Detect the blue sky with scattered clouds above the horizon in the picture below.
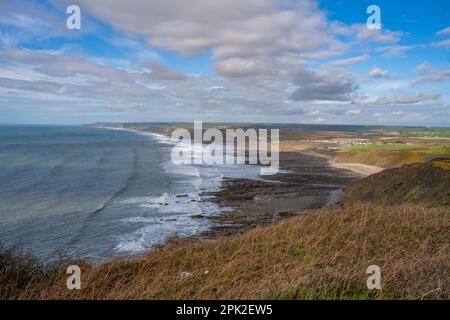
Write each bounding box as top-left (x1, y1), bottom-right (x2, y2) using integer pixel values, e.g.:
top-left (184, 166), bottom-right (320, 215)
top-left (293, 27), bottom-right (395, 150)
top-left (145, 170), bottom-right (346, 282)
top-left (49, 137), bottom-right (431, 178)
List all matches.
top-left (0, 0), bottom-right (450, 126)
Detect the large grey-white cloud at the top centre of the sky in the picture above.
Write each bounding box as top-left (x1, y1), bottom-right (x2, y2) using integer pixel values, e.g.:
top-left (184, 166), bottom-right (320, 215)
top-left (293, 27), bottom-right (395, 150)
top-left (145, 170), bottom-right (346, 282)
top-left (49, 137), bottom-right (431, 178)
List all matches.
top-left (74, 0), bottom-right (333, 58)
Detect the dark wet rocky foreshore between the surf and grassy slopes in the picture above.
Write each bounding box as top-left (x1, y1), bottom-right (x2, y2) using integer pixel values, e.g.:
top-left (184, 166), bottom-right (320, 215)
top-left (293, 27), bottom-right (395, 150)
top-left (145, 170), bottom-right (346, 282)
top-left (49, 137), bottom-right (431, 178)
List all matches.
top-left (202, 152), bottom-right (361, 238)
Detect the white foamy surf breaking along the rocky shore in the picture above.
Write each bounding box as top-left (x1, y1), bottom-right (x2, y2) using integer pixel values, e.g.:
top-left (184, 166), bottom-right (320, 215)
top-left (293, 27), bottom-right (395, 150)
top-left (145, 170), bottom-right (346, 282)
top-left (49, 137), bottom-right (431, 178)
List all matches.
top-left (99, 125), bottom-right (266, 253)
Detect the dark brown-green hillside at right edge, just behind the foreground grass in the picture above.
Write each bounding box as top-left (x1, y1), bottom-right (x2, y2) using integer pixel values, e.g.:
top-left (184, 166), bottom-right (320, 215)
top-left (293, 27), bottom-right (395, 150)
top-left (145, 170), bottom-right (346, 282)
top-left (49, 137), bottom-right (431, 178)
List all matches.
top-left (344, 159), bottom-right (450, 207)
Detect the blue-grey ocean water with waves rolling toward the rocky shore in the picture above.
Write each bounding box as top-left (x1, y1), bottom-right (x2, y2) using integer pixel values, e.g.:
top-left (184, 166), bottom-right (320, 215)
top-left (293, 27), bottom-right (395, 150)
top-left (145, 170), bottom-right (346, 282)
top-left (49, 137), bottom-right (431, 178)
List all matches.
top-left (0, 126), bottom-right (259, 262)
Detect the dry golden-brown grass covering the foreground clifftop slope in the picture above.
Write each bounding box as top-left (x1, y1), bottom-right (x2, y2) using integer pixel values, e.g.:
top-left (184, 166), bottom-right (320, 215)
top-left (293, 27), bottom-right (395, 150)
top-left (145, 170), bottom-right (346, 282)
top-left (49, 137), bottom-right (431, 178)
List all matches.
top-left (0, 205), bottom-right (450, 299)
